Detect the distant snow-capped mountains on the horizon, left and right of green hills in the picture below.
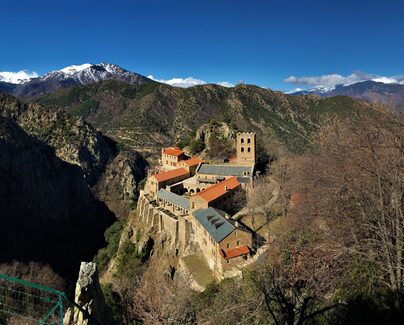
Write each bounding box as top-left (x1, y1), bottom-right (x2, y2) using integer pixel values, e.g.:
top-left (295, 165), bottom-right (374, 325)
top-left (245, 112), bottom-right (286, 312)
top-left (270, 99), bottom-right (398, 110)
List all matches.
top-left (0, 63), bottom-right (404, 113)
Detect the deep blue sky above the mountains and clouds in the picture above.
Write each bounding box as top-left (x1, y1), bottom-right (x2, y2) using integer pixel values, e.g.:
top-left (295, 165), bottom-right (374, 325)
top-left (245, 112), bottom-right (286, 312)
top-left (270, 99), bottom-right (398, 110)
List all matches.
top-left (0, 0), bottom-right (404, 90)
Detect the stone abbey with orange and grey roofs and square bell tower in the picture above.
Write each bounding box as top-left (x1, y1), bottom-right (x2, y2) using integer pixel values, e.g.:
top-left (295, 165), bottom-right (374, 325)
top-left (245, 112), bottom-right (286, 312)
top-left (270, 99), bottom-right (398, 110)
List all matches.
top-left (138, 132), bottom-right (256, 279)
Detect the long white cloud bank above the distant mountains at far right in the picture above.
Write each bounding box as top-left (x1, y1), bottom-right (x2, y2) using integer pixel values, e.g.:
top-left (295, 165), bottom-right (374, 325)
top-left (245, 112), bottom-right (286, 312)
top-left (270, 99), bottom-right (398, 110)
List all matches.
top-left (283, 72), bottom-right (404, 87)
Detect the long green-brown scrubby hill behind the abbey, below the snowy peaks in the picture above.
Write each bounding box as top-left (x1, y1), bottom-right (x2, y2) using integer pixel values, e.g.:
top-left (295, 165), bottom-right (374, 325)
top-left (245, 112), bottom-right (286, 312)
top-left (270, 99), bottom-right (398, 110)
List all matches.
top-left (36, 80), bottom-right (384, 152)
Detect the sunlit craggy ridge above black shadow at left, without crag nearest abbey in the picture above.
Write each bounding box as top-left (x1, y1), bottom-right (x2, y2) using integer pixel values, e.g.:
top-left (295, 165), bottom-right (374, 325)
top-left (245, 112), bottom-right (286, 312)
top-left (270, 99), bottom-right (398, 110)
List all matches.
top-left (0, 93), bottom-right (117, 186)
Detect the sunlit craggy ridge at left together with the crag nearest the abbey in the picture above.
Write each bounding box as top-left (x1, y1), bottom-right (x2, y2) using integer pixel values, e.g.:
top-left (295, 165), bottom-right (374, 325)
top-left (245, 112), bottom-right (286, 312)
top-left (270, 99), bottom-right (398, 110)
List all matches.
top-left (0, 92), bottom-right (147, 217)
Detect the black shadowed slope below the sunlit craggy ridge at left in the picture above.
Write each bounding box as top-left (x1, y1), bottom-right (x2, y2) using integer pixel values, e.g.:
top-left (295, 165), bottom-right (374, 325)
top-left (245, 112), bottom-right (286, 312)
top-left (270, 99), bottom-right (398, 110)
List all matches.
top-left (0, 117), bottom-right (115, 278)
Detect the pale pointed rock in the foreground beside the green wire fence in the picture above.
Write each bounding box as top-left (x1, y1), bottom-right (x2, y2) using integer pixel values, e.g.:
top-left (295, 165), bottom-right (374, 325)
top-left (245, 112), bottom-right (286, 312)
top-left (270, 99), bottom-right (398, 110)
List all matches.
top-left (64, 262), bottom-right (113, 325)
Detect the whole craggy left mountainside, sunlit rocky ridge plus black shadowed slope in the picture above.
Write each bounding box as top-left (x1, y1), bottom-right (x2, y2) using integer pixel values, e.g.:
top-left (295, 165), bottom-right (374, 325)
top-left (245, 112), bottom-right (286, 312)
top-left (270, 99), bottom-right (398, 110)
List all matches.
top-left (0, 92), bottom-right (146, 279)
